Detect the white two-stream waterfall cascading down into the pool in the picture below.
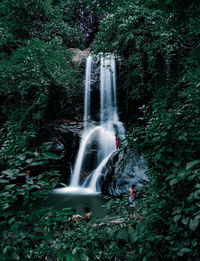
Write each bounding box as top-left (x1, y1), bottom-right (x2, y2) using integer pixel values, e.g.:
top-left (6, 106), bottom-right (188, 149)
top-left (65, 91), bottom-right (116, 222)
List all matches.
top-left (70, 55), bottom-right (124, 192)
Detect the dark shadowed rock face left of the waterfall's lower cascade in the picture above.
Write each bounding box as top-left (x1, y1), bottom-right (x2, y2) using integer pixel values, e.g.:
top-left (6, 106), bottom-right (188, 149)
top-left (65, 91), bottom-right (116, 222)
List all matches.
top-left (36, 120), bottom-right (83, 183)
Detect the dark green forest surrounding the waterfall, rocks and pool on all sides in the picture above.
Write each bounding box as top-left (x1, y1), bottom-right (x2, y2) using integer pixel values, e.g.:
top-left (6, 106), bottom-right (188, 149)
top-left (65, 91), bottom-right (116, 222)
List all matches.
top-left (0, 0), bottom-right (200, 261)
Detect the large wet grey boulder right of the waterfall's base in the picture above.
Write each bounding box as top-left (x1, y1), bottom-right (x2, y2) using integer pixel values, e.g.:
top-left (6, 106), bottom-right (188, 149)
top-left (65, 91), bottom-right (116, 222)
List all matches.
top-left (100, 148), bottom-right (148, 196)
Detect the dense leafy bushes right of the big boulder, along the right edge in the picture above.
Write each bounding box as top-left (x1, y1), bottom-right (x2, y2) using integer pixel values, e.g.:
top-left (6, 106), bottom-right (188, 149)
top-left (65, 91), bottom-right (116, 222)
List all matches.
top-left (125, 83), bottom-right (200, 260)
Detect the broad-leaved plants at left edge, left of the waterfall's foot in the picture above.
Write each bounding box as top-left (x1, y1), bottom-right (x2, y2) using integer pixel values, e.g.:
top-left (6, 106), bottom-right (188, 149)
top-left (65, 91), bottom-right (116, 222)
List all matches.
top-left (0, 146), bottom-right (60, 211)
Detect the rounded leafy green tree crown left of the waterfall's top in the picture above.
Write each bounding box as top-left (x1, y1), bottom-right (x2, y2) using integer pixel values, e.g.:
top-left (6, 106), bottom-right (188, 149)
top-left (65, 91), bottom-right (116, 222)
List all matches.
top-left (0, 38), bottom-right (83, 122)
